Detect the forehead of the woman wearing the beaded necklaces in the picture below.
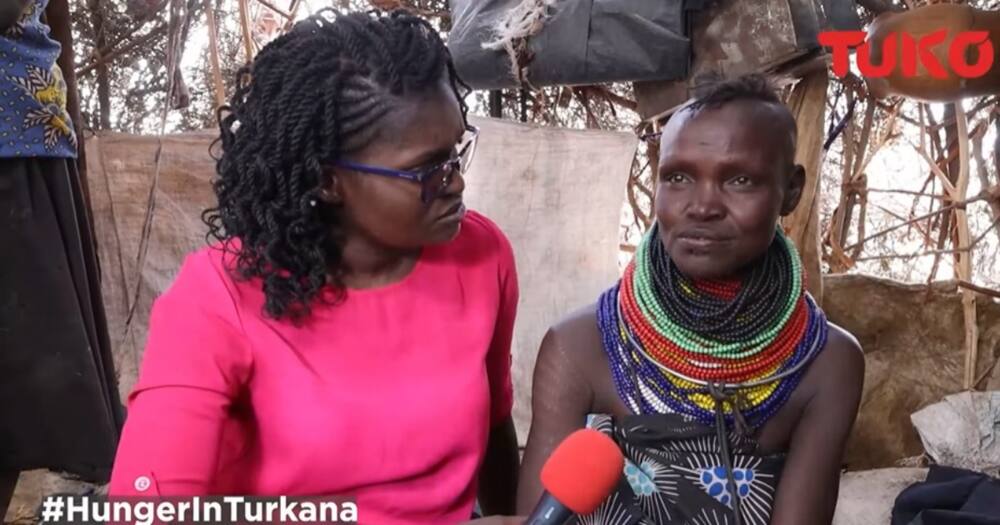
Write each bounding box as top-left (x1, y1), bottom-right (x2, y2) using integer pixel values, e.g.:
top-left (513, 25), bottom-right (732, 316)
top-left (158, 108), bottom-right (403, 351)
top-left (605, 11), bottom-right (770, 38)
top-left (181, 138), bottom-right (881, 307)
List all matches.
top-left (660, 101), bottom-right (795, 167)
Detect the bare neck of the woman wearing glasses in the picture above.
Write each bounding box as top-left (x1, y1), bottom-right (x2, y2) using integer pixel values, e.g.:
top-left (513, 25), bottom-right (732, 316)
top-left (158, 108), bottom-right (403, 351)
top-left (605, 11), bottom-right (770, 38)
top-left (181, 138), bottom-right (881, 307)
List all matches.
top-left (332, 235), bottom-right (420, 289)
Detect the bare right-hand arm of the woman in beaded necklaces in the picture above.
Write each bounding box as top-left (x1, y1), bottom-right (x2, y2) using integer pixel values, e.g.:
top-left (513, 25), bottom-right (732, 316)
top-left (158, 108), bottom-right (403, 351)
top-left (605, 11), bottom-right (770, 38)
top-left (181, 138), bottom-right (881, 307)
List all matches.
top-left (771, 327), bottom-right (865, 525)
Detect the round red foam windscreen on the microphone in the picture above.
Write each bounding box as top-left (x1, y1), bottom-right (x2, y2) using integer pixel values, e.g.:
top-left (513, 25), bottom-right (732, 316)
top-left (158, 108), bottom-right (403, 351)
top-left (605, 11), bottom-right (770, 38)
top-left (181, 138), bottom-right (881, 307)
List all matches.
top-left (541, 429), bottom-right (625, 515)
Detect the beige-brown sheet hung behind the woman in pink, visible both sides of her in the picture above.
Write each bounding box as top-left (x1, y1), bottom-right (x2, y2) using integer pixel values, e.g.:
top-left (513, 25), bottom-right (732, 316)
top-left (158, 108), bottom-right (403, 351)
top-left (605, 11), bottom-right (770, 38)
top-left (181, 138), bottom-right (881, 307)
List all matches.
top-left (87, 117), bottom-right (638, 443)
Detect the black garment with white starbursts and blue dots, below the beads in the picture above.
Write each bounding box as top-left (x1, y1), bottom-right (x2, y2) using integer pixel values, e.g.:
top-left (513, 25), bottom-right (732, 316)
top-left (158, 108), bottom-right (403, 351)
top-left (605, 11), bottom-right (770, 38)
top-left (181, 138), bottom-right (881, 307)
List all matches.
top-left (571, 414), bottom-right (785, 525)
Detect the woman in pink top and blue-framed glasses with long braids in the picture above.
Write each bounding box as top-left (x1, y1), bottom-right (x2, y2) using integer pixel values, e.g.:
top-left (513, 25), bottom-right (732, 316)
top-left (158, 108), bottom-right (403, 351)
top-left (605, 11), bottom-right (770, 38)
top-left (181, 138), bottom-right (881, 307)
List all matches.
top-left (110, 11), bottom-right (518, 525)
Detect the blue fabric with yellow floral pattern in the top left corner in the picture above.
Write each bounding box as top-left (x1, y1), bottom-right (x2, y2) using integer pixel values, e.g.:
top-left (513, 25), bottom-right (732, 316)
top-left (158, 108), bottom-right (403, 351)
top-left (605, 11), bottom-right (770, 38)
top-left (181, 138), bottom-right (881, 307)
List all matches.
top-left (0, 0), bottom-right (76, 158)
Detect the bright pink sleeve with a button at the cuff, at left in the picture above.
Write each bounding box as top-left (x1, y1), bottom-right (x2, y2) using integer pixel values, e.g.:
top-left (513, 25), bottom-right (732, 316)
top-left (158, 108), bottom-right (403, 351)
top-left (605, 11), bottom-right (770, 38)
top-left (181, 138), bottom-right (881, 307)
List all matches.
top-left (109, 256), bottom-right (251, 496)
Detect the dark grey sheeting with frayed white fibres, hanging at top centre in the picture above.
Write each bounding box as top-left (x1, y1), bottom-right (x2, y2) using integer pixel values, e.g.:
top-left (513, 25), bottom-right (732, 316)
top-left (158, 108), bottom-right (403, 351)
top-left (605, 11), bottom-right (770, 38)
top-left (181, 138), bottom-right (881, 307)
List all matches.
top-left (448, 0), bottom-right (702, 89)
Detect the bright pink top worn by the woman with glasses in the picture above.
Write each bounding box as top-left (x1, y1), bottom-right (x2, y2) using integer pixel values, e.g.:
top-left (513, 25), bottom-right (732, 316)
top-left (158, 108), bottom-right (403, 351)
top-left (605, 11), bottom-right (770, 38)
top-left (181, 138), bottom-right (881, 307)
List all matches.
top-left (109, 211), bottom-right (518, 525)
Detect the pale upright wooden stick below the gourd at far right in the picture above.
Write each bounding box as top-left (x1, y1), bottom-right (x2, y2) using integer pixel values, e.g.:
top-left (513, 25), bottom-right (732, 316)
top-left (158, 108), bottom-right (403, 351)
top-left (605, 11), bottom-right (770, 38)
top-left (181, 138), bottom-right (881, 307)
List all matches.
top-left (954, 102), bottom-right (979, 390)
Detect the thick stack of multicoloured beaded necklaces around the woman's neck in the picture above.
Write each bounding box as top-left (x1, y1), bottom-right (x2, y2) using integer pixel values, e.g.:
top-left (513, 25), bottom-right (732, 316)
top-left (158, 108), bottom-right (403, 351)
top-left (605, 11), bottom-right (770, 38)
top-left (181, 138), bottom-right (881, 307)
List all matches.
top-left (597, 226), bottom-right (828, 428)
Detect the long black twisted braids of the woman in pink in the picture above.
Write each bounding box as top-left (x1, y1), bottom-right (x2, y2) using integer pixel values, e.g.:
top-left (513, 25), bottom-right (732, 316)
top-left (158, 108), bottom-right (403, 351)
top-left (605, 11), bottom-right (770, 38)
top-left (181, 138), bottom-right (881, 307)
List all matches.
top-left (202, 9), bottom-right (469, 320)
